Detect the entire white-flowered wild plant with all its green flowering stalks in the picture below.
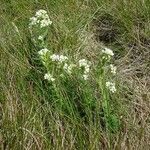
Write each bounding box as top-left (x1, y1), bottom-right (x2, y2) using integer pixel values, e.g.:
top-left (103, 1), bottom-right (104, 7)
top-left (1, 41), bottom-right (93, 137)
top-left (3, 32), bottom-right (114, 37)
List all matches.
top-left (29, 10), bottom-right (117, 140)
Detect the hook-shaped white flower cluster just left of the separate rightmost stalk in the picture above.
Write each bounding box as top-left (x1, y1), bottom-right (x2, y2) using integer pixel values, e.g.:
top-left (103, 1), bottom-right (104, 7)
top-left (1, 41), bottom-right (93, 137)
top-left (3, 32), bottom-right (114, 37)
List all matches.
top-left (79, 59), bottom-right (91, 80)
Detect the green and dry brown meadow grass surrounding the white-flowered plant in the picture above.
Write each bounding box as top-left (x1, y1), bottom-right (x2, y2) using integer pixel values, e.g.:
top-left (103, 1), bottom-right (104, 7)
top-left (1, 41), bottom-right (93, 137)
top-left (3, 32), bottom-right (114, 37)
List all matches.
top-left (0, 0), bottom-right (150, 150)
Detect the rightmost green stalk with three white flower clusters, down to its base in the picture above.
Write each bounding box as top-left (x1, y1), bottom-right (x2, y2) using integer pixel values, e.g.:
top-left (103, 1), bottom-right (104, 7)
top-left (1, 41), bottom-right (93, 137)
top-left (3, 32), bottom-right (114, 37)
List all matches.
top-left (96, 48), bottom-right (118, 136)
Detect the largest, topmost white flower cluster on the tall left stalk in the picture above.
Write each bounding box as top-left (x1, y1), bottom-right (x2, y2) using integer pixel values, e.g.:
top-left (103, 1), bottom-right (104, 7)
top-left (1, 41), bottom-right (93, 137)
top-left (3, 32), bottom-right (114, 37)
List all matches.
top-left (29, 9), bottom-right (52, 28)
